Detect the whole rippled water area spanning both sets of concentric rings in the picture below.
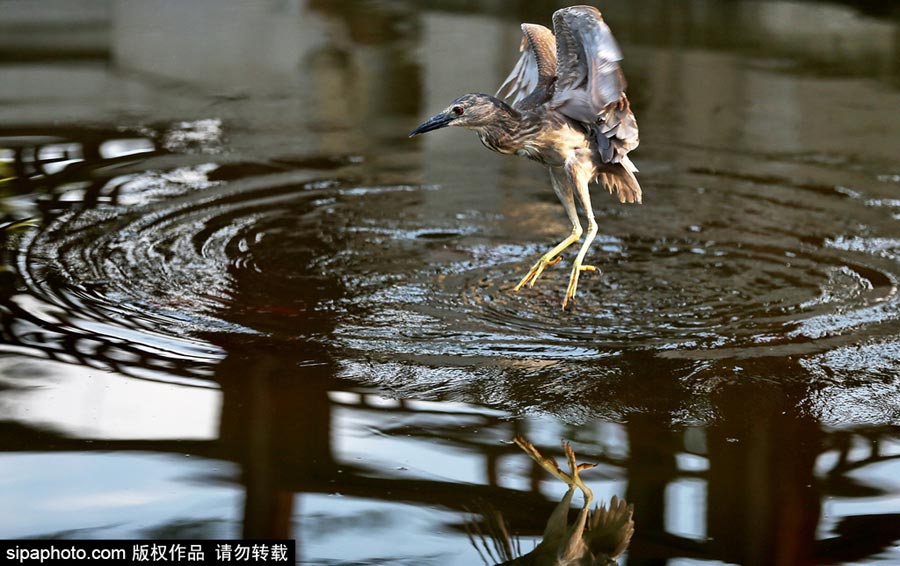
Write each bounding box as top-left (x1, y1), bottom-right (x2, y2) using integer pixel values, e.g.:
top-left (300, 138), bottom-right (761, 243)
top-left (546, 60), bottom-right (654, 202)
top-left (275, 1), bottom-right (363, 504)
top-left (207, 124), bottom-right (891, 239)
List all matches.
top-left (7, 132), bottom-right (900, 404)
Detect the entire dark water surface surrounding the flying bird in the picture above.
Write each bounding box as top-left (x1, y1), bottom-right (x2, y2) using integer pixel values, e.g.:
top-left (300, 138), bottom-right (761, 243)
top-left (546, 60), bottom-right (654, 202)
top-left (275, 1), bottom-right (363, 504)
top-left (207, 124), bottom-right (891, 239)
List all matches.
top-left (0, 0), bottom-right (900, 565)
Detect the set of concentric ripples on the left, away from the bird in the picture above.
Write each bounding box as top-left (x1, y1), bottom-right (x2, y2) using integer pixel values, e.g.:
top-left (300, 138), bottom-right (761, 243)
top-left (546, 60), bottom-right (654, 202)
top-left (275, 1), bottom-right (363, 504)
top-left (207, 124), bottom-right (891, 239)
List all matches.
top-left (19, 164), bottom-right (402, 342)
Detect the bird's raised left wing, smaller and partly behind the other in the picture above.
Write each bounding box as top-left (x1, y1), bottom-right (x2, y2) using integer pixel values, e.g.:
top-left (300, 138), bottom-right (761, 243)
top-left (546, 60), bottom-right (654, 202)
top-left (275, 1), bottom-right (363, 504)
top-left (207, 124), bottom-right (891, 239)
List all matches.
top-left (497, 24), bottom-right (556, 106)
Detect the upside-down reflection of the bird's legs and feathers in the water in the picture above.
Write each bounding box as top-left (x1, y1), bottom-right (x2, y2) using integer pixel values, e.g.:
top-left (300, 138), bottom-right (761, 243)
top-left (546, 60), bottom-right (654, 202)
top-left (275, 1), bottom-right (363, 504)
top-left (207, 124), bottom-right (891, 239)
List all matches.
top-left (470, 437), bottom-right (634, 566)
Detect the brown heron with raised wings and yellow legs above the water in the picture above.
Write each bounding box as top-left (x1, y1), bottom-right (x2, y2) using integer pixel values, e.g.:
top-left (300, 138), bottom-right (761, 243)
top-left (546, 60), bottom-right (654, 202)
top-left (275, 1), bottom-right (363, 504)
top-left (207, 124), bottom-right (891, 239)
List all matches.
top-left (410, 6), bottom-right (641, 308)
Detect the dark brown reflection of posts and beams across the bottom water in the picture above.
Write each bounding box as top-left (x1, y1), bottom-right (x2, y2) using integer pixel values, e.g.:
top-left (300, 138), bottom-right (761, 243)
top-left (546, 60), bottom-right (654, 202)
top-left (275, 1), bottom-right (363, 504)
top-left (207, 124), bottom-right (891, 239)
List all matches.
top-left (0, 346), bottom-right (900, 564)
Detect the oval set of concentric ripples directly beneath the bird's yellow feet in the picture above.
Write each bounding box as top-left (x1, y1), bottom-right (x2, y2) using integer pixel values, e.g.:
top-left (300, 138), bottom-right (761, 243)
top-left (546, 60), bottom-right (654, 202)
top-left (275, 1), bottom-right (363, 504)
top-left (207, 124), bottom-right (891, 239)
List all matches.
top-left (442, 235), bottom-right (897, 356)
